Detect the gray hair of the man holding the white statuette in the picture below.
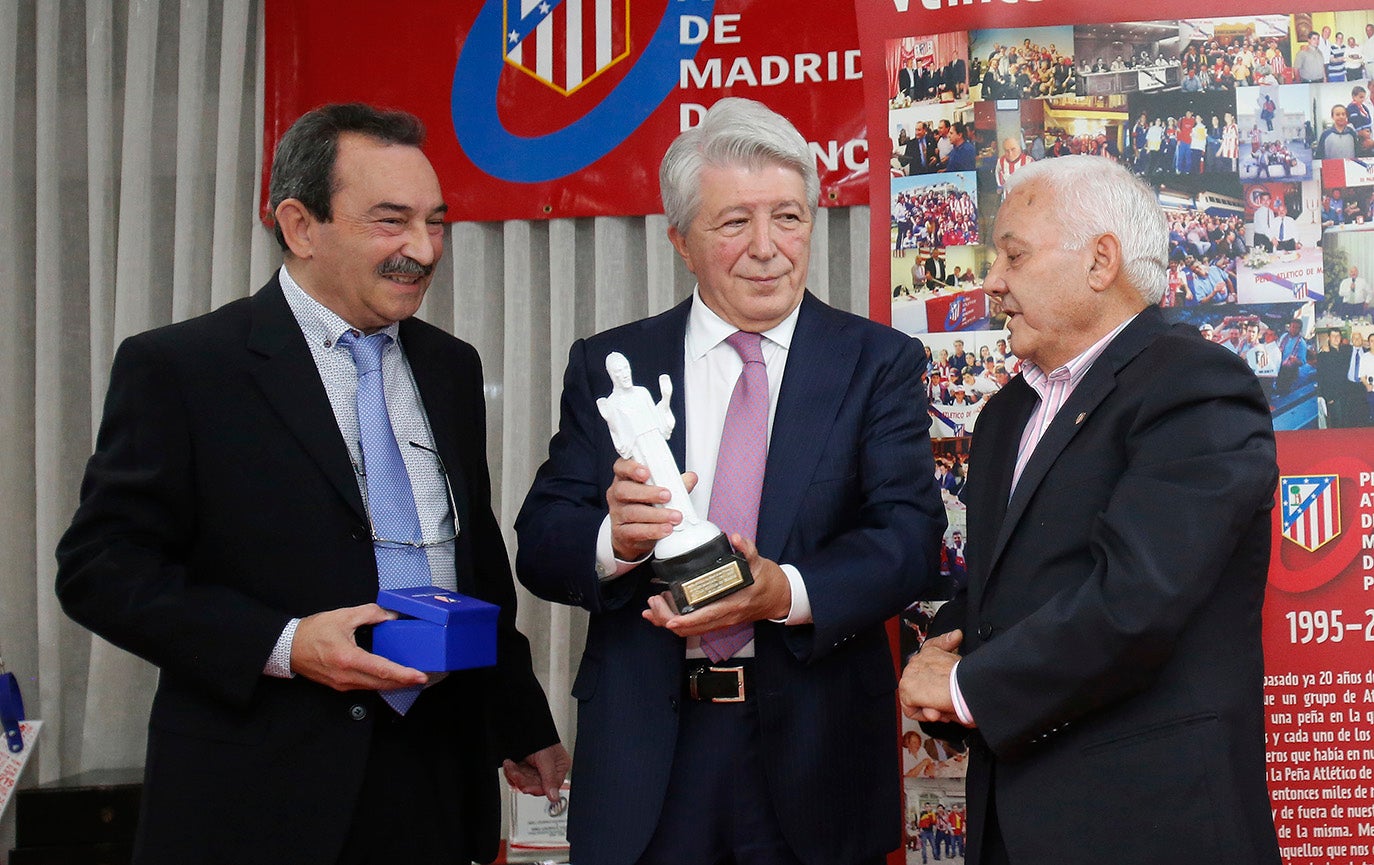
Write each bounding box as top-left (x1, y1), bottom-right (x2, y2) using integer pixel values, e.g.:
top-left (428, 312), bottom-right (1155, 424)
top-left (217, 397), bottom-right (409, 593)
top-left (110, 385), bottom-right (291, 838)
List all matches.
top-left (658, 97), bottom-right (820, 233)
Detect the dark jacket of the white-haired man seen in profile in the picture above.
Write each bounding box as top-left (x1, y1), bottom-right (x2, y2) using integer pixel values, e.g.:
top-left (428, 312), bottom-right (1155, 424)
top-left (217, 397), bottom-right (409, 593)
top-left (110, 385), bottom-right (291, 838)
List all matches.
top-left (930, 308), bottom-right (1278, 865)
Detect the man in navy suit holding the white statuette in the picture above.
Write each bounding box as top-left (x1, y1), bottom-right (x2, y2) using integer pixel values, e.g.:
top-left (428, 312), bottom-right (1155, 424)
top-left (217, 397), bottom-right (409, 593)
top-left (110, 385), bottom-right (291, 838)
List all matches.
top-left (515, 99), bottom-right (945, 865)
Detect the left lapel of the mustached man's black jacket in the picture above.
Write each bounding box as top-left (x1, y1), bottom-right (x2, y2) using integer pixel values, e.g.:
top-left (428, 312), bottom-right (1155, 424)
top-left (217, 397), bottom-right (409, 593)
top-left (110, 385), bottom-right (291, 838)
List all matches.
top-left (247, 276), bottom-right (364, 519)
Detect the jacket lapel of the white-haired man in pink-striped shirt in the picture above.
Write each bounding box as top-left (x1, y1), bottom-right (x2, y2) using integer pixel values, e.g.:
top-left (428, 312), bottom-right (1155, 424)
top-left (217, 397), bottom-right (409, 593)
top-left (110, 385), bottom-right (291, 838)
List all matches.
top-left (988, 306), bottom-right (1168, 573)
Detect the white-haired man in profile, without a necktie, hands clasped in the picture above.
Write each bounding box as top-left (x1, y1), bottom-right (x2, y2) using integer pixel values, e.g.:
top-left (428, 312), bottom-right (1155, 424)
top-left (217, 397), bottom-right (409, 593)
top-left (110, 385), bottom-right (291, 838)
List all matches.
top-left (901, 157), bottom-right (1279, 865)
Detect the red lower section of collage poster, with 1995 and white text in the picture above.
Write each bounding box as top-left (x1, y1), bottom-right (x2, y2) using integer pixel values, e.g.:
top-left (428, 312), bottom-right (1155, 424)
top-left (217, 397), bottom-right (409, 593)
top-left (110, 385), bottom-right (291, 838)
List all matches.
top-left (1264, 430), bottom-right (1374, 865)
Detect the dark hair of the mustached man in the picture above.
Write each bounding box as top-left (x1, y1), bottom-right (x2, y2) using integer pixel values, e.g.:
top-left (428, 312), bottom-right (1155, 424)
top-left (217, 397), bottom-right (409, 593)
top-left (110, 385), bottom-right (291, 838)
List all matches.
top-left (268, 102), bottom-right (425, 253)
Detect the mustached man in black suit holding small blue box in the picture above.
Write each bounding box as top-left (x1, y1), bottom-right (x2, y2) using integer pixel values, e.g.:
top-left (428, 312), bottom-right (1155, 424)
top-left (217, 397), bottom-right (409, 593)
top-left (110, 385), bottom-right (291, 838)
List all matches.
top-left (58, 104), bottom-right (567, 865)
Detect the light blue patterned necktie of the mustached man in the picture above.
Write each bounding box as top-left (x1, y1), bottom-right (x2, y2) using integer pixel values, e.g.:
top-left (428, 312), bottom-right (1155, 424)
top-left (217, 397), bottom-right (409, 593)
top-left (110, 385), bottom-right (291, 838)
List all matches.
top-left (339, 331), bottom-right (433, 715)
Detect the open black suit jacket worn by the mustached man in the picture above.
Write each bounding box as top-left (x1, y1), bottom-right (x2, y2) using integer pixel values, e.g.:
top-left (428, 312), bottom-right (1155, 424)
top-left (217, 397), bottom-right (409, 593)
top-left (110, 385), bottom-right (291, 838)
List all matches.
top-left (58, 277), bottom-right (556, 865)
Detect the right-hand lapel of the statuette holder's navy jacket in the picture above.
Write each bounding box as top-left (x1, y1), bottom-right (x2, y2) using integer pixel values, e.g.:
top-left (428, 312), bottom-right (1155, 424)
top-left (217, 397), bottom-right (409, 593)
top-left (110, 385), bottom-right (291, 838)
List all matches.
top-left (757, 291), bottom-right (860, 557)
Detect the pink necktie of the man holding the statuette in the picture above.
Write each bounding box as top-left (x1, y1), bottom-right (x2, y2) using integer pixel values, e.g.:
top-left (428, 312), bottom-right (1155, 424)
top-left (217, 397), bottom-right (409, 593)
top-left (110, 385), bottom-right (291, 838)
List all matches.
top-left (701, 331), bottom-right (768, 663)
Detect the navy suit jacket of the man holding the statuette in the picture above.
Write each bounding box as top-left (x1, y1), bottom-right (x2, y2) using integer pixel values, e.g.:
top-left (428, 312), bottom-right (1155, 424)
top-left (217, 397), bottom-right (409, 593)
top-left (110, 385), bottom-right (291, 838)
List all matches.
top-left (515, 294), bottom-right (945, 865)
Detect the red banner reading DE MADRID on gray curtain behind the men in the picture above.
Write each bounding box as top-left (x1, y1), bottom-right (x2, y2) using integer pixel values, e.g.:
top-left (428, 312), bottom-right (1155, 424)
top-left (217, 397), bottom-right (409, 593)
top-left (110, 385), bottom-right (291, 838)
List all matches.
top-left (261, 0), bottom-right (868, 220)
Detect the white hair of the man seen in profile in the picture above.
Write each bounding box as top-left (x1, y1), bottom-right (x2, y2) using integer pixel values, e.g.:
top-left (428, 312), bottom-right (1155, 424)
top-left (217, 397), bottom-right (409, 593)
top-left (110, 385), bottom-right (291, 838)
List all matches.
top-left (1006, 155), bottom-right (1169, 306)
